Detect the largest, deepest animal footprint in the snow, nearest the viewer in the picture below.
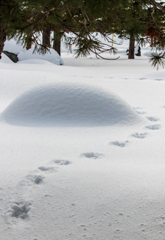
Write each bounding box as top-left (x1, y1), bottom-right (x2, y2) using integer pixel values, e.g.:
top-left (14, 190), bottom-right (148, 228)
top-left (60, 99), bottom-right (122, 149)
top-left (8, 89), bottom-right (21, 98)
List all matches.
top-left (9, 201), bottom-right (31, 219)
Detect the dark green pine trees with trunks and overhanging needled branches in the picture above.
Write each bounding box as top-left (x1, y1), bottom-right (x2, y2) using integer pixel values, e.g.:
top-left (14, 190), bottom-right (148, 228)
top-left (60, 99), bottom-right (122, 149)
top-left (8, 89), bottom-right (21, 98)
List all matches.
top-left (0, 0), bottom-right (165, 66)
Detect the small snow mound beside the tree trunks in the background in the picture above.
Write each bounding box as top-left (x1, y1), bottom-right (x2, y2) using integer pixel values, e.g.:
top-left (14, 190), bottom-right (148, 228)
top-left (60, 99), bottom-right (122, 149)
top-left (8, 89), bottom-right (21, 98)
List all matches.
top-left (18, 48), bottom-right (64, 65)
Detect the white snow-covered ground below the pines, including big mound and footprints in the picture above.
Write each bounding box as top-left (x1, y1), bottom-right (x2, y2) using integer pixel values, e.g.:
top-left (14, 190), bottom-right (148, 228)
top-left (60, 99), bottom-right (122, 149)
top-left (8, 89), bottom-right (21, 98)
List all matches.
top-left (0, 36), bottom-right (165, 240)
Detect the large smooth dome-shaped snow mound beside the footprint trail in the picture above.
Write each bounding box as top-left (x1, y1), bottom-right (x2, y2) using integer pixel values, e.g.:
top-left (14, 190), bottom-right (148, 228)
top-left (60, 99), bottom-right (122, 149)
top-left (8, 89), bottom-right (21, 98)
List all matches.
top-left (2, 84), bottom-right (142, 127)
